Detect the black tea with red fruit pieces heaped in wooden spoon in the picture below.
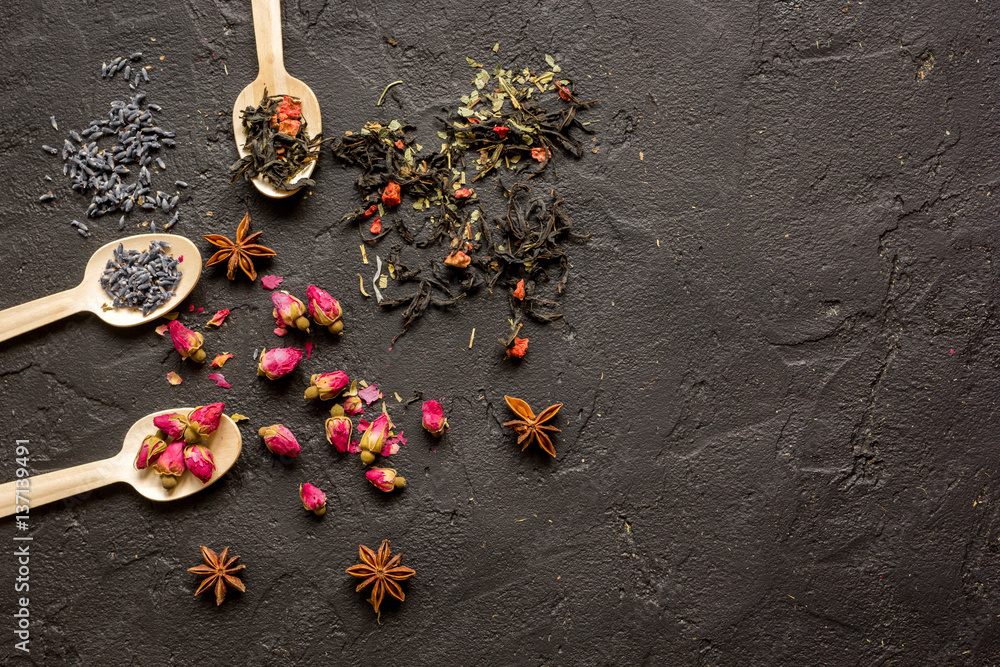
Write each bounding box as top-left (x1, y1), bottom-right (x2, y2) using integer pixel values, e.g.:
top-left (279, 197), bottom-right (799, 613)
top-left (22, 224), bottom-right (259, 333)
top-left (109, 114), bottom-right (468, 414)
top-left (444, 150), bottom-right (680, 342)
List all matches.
top-left (229, 90), bottom-right (322, 190)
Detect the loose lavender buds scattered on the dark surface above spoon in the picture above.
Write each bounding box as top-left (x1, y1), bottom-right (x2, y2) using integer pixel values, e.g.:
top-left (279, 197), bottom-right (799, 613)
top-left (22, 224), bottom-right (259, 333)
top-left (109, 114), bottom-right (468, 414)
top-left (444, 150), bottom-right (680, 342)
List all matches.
top-left (42, 93), bottom-right (186, 237)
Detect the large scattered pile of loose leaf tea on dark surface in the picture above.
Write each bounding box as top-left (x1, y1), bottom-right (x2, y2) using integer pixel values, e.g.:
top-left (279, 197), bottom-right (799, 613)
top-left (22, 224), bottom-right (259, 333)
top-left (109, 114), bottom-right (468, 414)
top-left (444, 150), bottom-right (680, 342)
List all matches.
top-left (333, 56), bottom-right (594, 357)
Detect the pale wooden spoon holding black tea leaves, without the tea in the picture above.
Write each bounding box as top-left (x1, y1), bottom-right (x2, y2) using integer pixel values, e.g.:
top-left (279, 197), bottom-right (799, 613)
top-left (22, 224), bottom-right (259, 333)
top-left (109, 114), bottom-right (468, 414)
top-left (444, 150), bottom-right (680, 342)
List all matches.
top-left (233, 0), bottom-right (323, 199)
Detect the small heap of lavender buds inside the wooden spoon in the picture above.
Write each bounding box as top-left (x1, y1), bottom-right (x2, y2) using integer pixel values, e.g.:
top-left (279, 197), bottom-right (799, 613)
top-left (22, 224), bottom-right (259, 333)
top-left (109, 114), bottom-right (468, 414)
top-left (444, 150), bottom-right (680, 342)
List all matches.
top-left (101, 241), bottom-right (181, 317)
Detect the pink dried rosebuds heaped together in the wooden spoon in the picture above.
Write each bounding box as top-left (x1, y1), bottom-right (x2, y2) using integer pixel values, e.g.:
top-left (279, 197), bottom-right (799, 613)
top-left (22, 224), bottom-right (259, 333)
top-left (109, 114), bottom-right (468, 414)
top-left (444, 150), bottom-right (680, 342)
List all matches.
top-left (134, 403), bottom-right (226, 489)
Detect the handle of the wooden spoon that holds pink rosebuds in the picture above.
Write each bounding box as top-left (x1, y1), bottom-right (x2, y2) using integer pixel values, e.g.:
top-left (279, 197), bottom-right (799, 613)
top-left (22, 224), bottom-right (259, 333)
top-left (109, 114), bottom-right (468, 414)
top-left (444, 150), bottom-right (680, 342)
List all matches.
top-left (0, 458), bottom-right (121, 518)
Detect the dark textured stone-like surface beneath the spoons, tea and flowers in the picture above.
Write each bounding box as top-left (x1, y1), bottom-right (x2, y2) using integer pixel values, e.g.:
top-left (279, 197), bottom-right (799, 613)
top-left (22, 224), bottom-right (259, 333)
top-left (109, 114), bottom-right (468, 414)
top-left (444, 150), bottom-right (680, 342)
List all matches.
top-left (0, 0), bottom-right (1000, 666)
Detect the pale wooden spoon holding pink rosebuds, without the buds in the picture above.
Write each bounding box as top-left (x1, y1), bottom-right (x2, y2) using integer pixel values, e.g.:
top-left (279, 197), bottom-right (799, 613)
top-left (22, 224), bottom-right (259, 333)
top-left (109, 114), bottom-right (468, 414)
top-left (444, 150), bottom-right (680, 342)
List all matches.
top-left (0, 408), bottom-right (243, 517)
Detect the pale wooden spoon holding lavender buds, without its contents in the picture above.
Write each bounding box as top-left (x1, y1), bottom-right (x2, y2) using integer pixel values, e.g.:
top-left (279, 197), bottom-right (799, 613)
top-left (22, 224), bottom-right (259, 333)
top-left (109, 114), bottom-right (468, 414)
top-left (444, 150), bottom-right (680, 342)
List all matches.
top-left (0, 234), bottom-right (201, 341)
